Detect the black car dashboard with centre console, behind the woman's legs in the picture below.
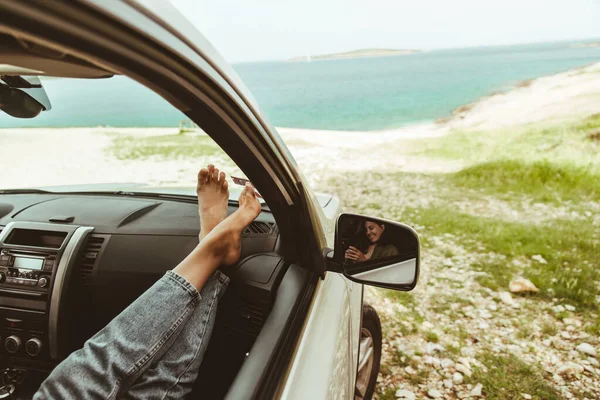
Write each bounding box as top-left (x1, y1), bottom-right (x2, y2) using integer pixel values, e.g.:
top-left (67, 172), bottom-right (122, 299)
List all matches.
top-left (0, 193), bottom-right (289, 398)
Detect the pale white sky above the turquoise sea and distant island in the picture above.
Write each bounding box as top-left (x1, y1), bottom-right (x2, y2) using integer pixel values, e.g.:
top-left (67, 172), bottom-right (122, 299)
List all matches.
top-left (171, 0), bottom-right (600, 62)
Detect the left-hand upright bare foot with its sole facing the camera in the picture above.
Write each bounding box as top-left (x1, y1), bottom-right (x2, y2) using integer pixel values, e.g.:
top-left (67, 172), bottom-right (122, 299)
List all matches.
top-left (196, 164), bottom-right (229, 240)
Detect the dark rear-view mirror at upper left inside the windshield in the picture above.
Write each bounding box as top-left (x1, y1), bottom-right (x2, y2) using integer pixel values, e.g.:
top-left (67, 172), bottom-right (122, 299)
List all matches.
top-left (0, 75), bottom-right (51, 118)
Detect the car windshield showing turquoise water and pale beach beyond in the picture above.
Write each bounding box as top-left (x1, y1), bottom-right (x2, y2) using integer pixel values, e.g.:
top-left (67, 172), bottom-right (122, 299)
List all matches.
top-left (0, 76), bottom-right (251, 200)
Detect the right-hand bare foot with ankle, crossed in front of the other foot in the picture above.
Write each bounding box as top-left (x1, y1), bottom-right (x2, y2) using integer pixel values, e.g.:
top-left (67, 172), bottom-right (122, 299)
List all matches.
top-left (204, 183), bottom-right (261, 265)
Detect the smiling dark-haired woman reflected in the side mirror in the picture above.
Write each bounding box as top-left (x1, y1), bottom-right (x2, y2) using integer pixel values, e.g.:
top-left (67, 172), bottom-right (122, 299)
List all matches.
top-left (344, 221), bottom-right (399, 262)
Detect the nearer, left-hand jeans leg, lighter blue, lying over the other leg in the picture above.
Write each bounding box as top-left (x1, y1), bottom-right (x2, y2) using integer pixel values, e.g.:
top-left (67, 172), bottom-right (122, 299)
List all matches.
top-left (34, 271), bottom-right (201, 400)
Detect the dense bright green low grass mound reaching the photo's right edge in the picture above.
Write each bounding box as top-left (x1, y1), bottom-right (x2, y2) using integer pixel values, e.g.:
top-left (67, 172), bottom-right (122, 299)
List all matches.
top-left (449, 160), bottom-right (600, 203)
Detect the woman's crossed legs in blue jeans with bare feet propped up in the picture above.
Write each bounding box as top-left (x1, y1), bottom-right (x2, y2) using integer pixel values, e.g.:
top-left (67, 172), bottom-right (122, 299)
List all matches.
top-left (34, 166), bottom-right (260, 399)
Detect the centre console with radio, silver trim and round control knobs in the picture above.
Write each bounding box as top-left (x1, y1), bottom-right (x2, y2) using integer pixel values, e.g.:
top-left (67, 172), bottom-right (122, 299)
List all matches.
top-left (0, 221), bottom-right (93, 366)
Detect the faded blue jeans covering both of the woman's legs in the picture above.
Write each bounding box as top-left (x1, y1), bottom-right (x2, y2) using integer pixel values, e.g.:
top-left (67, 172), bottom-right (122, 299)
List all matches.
top-left (34, 271), bottom-right (229, 400)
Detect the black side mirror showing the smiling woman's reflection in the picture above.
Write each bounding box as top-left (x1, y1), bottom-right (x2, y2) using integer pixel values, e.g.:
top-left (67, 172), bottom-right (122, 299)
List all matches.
top-left (333, 213), bottom-right (420, 291)
